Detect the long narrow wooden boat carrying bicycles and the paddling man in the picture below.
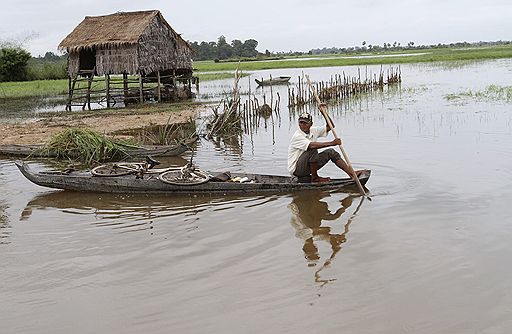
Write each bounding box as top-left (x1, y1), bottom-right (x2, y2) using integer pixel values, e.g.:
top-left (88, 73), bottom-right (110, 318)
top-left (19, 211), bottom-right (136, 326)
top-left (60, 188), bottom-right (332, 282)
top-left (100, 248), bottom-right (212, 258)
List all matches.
top-left (16, 162), bottom-right (371, 194)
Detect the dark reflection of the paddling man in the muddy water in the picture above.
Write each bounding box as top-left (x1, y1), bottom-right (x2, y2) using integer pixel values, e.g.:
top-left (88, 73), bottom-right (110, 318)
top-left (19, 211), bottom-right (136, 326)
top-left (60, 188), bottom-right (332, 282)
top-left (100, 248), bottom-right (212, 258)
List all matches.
top-left (288, 192), bottom-right (364, 286)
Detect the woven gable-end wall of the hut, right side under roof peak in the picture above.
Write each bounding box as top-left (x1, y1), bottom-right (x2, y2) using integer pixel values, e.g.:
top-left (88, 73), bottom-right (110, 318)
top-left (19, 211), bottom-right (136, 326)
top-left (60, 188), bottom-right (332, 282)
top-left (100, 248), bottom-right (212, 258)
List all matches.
top-left (138, 15), bottom-right (192, 74)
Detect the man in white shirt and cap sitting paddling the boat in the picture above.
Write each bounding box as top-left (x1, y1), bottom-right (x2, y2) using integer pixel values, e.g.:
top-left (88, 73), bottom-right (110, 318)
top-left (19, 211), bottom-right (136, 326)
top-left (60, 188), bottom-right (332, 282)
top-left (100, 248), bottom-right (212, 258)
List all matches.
top-left (288, 103), bottom-right (363, 182)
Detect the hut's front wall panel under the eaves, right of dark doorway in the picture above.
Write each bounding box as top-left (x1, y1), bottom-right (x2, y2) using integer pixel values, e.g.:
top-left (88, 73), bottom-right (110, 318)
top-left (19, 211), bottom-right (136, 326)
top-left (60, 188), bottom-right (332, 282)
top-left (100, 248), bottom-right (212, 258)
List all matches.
top-left (96, 44), bottom-right (138, 75)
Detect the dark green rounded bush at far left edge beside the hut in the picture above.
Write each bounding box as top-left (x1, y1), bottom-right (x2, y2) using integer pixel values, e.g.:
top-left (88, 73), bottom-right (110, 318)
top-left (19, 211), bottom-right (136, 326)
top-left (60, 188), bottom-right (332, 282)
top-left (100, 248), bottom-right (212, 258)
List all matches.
top-left (0, 46), bottom-right (31, 81)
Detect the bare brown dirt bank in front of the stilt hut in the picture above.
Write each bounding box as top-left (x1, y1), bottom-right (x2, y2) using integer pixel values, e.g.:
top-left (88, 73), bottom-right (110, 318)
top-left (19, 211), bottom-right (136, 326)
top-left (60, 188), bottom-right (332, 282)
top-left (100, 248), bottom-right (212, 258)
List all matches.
top-left (0, 105), bottom-right (207, 145)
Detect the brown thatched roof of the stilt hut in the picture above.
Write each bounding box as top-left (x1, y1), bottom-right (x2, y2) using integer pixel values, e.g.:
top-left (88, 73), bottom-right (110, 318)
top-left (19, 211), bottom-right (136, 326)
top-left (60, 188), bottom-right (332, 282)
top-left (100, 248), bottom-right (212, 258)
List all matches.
top-left (59, 10), bottom-right (190, 52)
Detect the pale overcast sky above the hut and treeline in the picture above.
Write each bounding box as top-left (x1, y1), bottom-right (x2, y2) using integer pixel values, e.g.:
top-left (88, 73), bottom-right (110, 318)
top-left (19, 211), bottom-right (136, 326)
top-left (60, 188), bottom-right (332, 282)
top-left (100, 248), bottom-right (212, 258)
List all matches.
top-left (0, 0), bottom-right (512, 56)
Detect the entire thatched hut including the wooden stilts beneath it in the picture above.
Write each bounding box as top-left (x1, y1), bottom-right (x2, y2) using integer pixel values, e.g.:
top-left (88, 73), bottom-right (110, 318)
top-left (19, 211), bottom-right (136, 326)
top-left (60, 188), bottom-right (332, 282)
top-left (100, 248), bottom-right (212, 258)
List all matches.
top-left (59, 10), bottom-right (198, 110)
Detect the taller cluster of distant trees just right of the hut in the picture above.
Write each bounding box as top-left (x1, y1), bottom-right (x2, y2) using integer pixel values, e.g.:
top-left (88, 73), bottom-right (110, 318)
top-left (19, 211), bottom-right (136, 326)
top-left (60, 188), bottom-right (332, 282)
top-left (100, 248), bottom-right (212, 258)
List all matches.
top-left (189, 36), bottom-right (260, 61)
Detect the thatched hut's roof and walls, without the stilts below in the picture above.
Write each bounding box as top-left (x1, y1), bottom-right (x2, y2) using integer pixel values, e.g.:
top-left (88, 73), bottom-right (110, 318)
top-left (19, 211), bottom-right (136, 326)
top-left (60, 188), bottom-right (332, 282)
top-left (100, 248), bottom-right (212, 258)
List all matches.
top-left (59, 10), bottom-right (192, 77)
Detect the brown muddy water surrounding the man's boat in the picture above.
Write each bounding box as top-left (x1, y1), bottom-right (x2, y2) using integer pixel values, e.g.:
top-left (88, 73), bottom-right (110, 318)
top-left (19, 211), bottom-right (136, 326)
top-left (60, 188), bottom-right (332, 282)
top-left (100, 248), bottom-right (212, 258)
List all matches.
top-left (0, 60), bottom-right (512, 334)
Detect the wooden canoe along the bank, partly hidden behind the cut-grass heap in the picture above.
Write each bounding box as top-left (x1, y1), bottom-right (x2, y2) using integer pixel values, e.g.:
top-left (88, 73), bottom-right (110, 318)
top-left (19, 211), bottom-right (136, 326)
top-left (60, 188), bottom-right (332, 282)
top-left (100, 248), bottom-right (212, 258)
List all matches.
top-left (0, 139), bottom-right (195, 158)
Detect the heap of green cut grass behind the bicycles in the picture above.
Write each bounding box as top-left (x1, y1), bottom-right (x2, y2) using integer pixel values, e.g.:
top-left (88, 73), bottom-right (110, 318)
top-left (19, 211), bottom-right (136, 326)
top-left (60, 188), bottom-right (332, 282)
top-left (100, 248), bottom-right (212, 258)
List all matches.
top-left (42, 128), bottom-right (136, 165)
